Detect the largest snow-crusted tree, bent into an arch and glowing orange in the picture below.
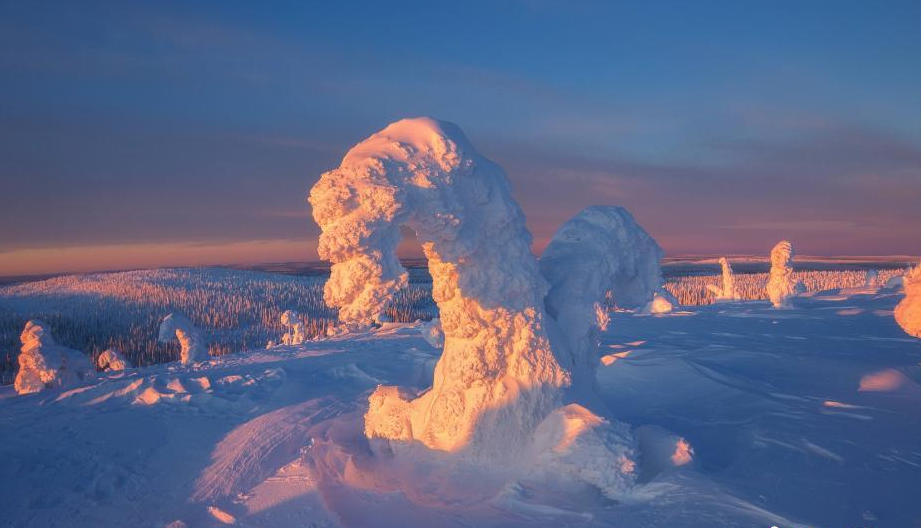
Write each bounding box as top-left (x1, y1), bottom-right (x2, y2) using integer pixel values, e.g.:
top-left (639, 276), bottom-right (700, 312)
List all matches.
top-left (309, 118), bottom-right (569, 459)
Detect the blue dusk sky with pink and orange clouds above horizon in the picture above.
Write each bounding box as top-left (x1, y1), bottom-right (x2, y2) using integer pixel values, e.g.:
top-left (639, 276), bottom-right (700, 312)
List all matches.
top-left (0, 0), bottom-right (921, 275)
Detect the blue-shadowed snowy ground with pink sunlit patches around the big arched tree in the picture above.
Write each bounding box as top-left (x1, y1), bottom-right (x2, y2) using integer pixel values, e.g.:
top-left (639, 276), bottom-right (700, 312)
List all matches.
top-left (0, 288), bottom-right (921, 527)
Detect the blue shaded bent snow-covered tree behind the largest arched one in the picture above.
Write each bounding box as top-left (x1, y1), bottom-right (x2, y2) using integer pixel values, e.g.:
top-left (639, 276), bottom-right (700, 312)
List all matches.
top-left (540, 206), bottom-right (662, 391)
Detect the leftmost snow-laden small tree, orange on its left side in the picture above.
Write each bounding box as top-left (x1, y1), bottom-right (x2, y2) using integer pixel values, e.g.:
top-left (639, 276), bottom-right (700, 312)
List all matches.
top-left (13, 319), bottom-right (95, 394)
